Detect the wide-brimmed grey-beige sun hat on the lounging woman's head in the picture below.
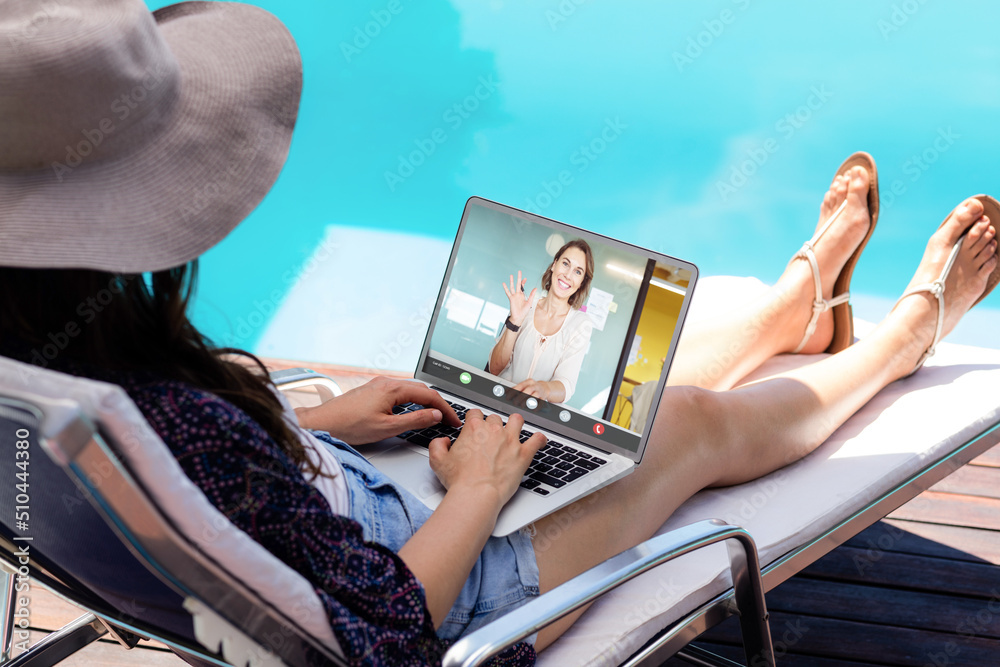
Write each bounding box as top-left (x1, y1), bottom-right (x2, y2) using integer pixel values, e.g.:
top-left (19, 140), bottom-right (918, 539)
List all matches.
top-left (0, 0), bottom-right (302, 273)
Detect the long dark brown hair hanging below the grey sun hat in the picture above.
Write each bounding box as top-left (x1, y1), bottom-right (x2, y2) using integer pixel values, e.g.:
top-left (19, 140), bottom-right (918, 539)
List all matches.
top-left (0, 260), bottom-right (320, 475)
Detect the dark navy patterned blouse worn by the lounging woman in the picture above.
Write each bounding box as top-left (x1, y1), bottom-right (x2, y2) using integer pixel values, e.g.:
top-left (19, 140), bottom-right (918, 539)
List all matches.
top-left (91, 374), bottom-right (535, 667)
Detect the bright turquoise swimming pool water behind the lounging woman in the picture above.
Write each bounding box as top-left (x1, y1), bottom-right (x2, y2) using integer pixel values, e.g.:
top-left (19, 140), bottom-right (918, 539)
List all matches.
top-left (149, 0), bottom-right (1000, 368)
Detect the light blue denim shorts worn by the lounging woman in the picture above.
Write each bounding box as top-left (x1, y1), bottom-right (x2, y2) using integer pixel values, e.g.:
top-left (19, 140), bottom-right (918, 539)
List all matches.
top-left (314, 432), bottom-right (538, 641)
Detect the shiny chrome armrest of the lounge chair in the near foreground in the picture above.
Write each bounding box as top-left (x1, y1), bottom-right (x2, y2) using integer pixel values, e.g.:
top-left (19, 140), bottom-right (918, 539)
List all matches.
top-left (442, 519), bottom-right (774, 667)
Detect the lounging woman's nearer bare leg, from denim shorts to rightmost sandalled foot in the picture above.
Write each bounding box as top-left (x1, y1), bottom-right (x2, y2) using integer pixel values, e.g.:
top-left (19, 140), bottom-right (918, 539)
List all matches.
top-left (534, 200), bottom-right (997, 649)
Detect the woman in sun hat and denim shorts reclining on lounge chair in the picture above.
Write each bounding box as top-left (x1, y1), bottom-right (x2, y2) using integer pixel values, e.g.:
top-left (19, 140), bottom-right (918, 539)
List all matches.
top-left (0, 0), bottom-right (1000, 664)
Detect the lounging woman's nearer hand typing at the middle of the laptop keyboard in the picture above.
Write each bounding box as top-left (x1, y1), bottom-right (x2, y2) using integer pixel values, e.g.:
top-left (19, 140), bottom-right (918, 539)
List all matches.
top-left (429, 410), bottom-right (546, 508)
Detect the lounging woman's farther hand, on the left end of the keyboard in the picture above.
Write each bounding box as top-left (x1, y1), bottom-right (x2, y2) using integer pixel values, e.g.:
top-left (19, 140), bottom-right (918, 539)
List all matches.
top-left (295, 377), bottom-right (462, 445)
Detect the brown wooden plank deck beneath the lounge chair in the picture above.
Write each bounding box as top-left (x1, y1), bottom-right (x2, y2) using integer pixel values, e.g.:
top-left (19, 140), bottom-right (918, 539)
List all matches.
top-left (21, 367), bottom-right (1000, 667)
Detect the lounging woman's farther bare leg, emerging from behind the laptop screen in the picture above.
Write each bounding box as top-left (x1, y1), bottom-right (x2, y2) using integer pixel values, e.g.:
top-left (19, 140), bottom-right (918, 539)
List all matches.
top-left (668, 167), bottom-right (870, 390)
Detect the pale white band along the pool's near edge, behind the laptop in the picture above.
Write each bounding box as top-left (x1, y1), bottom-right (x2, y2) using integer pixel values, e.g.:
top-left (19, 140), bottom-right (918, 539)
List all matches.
top-left (254, 225), bottom-right (1000, 372)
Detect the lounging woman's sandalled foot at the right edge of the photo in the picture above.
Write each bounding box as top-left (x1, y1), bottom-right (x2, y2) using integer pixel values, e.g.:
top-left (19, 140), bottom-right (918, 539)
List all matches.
top-left (889, 198), bottom-right (998, 377)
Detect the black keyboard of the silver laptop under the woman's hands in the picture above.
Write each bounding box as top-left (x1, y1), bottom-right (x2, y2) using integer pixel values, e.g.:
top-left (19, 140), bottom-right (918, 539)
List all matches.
top-left (392, 401), bottom-right (607, 496)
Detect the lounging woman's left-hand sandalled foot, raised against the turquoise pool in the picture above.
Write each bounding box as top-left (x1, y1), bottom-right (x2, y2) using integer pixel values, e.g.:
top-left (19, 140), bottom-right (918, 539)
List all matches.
top-left (777, 166), bottom-right (872, 354)
